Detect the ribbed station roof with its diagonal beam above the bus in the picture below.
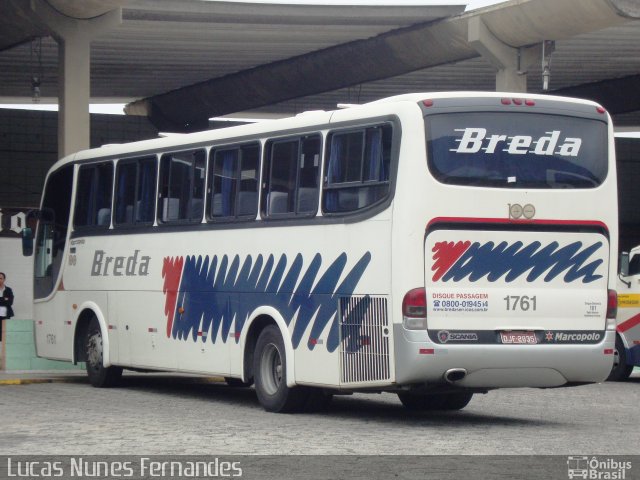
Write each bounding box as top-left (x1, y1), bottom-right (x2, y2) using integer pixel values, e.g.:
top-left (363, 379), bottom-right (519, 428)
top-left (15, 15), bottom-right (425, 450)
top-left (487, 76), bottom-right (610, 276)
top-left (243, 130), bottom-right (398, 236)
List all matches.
top-left (0, 0), bottom-right (640, 131)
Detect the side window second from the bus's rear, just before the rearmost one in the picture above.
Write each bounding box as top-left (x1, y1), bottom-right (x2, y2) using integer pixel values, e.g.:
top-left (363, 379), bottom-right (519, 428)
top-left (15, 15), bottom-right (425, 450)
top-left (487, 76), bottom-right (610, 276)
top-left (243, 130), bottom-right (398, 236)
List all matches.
top-left (262, 135), bottom-right (321, 217)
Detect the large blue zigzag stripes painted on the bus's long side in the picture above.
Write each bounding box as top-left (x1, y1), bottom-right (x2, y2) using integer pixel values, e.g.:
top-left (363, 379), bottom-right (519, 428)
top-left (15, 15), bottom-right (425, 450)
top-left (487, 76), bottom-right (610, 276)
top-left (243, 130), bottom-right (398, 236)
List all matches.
top-left (171, 252), bottom-right (371, 352)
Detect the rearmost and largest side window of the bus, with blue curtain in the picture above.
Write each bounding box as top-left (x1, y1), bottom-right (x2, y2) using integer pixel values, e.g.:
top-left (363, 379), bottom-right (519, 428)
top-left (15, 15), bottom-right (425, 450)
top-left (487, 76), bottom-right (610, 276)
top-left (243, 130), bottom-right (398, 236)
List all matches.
top-left (322, 124), bottom-right (392, 213)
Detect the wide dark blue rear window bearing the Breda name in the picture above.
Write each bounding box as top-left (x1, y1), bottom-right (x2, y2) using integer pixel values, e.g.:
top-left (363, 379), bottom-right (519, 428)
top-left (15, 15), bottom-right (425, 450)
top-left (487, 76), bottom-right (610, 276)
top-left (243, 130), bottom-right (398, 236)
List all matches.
top-left (425, 112), bottom-right (608, 189)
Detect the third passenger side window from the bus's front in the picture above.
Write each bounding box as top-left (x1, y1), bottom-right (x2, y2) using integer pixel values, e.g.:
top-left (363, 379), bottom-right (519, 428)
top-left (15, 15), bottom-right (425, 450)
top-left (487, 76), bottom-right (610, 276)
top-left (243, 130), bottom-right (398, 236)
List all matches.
top-left (158, 150), bottom-right (206, 223)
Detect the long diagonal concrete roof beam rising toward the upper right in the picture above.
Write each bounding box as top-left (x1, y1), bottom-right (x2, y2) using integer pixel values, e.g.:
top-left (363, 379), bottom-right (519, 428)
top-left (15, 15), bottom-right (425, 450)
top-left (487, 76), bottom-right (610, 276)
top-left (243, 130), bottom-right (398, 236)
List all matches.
top-left (125, 0), bottom-right (640, 131)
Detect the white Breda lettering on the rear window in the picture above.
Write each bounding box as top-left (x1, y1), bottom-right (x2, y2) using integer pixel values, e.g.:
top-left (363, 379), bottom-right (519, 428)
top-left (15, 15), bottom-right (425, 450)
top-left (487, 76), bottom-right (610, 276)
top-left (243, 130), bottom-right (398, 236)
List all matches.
top-left (450, 128), bottom-right (582, 157)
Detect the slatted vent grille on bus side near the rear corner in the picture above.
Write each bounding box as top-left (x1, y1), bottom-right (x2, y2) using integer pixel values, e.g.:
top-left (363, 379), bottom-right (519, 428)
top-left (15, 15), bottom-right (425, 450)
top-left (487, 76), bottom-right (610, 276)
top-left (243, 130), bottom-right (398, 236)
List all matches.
top-left (339, 295), bottom-right (390, 383)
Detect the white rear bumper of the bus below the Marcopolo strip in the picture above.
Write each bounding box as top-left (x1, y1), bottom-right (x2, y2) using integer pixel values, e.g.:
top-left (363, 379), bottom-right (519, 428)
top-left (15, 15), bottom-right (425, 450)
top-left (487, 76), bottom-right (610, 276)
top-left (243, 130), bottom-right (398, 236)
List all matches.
top-left (394, 325), bottom-right (616, 388)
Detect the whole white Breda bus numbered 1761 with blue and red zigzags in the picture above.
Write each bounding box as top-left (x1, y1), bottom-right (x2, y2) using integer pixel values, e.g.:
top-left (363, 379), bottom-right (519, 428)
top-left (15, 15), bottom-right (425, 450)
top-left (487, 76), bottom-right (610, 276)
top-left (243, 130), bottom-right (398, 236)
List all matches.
top-left (25, 92), bottom-right (618, 412)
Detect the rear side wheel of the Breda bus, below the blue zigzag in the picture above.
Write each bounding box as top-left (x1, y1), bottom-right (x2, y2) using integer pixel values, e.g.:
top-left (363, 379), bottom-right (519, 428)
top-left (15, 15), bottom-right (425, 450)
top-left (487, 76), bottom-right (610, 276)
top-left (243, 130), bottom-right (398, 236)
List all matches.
top-left (253, 325), bottom-right (309, 413)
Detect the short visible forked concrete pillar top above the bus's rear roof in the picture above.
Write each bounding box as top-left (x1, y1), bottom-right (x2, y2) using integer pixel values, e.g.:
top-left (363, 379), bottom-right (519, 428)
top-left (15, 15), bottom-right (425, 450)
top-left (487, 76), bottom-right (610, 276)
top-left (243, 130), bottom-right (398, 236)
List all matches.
top-left (467, 17), bottom-right (542, 92)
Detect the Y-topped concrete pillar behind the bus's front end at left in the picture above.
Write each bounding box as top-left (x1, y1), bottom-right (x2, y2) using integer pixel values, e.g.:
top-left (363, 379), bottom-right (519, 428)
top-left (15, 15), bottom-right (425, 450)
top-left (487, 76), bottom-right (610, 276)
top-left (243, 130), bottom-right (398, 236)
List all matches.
top-left (31, 0), bottom-right (122, 158)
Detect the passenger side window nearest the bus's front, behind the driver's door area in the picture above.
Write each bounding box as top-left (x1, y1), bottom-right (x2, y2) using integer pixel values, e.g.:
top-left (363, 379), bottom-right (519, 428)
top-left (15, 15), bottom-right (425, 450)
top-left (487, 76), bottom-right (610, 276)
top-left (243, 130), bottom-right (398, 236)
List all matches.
top-left (73, 162), bottom-right (113, 228)
